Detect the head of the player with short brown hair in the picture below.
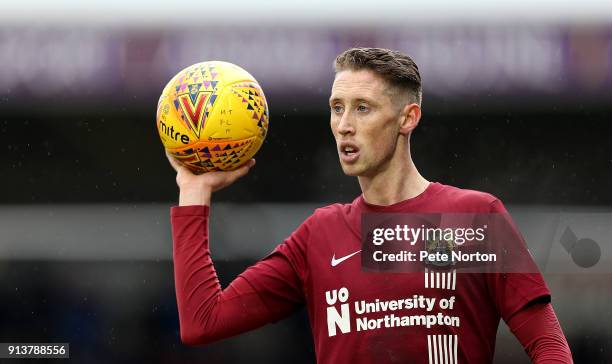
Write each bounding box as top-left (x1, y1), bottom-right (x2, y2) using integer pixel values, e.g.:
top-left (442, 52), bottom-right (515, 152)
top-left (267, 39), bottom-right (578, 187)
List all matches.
top-left (330, 48), bottom-right (422, 177)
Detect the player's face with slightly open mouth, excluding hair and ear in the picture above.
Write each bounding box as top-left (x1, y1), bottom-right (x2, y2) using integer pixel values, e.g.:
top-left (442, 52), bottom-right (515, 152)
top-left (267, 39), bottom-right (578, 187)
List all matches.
top-left (329, 70), bottom-right (400, 177)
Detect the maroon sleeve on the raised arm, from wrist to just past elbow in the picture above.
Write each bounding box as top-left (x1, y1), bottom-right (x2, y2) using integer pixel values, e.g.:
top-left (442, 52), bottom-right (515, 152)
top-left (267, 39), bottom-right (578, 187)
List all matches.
top-left (172, 206), bottom-right (270, 345)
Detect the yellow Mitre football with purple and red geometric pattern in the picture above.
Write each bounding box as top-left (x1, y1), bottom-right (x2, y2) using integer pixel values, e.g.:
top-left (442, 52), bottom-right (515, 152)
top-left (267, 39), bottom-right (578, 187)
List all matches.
top-left (156, 61), bottom-right (269, 173)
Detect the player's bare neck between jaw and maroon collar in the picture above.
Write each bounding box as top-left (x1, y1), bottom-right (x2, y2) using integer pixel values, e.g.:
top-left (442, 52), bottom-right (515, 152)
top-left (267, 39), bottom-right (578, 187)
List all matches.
top-left (358, 154), bottom-right (429, 206)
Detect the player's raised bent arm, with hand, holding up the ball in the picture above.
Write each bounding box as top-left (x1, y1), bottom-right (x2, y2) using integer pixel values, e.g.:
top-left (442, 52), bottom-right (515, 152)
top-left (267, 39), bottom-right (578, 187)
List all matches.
top-left (169, 157), bottom-right (302, 345)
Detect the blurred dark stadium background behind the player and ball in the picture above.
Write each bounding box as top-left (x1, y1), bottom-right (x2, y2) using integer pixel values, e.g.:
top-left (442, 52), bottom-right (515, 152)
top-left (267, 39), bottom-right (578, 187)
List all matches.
top-left (0, 0), bottom-right (612, 364)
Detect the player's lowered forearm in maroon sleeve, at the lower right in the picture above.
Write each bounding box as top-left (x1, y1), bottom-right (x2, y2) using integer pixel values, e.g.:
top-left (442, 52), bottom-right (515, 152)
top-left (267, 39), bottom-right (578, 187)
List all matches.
top-left (508, 303), bottom-right (573, 364)
